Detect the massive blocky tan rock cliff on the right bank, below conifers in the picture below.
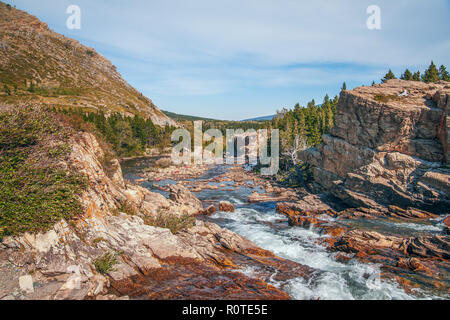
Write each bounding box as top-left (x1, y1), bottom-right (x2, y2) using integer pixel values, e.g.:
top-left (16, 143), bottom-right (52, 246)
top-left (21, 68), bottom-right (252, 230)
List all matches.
top-left (300, 80), bottom-right (450, 212)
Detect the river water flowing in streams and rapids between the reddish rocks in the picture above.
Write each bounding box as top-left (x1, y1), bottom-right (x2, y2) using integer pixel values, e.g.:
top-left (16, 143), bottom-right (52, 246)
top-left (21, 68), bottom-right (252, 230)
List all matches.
top-left (123, 161), bottom-right (440, 299)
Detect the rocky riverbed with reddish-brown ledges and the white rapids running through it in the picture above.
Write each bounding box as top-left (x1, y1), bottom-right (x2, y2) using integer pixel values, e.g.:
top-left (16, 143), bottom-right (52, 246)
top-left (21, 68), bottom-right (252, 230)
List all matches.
top-left (123, 160), bottom-right (450, 299)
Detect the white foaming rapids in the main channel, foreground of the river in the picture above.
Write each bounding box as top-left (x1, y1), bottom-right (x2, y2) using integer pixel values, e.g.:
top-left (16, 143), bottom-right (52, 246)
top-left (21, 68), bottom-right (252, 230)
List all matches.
top-left (215, 208), bottom-right (414, 300)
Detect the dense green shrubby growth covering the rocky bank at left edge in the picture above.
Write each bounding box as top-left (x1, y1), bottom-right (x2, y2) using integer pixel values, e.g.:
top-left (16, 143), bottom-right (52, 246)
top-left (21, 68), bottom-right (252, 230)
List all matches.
top-left (0, 107), bottom-right (87, 239)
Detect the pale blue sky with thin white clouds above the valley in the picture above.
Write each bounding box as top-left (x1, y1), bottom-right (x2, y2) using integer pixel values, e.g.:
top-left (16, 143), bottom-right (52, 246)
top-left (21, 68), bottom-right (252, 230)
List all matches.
top-left (3, 0), bottom-right (450, 120)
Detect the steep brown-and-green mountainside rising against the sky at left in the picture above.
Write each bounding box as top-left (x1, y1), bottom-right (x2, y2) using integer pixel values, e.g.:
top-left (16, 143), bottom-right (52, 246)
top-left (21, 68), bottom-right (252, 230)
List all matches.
top-left (0, 2), bottom-right (176, 125)
